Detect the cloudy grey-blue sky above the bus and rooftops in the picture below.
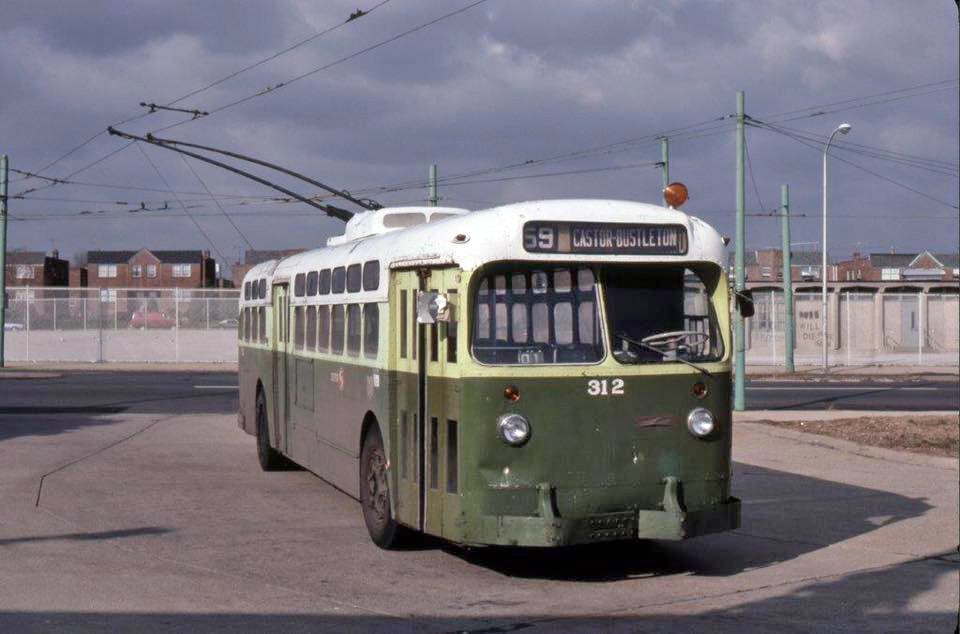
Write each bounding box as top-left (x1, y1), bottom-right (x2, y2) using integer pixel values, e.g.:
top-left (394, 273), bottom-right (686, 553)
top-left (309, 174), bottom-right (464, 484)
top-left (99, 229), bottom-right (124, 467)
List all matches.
top-left (0, 0), bottom-right (960, 274)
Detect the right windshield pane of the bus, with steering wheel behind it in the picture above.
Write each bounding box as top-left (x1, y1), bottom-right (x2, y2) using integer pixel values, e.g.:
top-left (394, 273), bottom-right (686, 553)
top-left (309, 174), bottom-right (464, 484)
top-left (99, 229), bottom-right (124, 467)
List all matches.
top-left (603, 266), bottom-right (723, 364)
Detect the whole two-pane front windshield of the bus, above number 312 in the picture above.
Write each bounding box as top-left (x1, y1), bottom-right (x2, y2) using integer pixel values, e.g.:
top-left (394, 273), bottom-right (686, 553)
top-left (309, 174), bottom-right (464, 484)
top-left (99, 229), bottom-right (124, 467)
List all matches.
top-left (471, 265), bottom-right (723, 365)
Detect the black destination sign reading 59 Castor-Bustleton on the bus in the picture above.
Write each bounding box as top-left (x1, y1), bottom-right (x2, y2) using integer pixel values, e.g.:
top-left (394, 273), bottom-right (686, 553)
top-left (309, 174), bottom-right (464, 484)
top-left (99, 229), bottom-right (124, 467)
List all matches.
top-left (523, 221), bottom-right (687, 255)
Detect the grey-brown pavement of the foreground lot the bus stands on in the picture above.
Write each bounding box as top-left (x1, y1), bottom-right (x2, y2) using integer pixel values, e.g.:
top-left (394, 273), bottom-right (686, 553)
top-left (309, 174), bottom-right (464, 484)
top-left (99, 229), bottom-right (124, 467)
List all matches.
top-left (0, 408), bottom-right (958, 634)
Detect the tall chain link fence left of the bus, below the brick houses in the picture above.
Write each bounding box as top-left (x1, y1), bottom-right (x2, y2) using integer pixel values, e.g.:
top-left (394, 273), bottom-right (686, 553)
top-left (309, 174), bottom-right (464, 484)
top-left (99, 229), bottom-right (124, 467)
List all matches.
top-left (4, 288), bottom-right (240, 363)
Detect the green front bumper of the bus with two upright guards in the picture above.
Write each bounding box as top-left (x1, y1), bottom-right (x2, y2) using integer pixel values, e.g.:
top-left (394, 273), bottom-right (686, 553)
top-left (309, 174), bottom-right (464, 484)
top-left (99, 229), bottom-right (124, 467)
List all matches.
top-left (470, 477), bottom-right (740, 546)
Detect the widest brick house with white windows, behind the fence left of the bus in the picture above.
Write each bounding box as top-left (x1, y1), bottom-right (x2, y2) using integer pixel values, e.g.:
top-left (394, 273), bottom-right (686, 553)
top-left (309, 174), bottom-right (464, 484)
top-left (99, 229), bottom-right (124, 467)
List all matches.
top-left (86, 249), bottom-right (217, 289)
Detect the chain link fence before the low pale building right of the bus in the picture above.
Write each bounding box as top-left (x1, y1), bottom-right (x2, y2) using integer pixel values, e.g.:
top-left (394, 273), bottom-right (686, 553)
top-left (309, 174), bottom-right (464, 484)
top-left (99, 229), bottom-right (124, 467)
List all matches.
top-left (744, 290), bottom-right (960, 366)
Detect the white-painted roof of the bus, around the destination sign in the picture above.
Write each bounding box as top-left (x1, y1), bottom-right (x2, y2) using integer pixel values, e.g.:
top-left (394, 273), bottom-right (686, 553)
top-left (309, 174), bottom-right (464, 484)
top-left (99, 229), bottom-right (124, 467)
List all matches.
top-left (244, 199), bottom-right (724, 294)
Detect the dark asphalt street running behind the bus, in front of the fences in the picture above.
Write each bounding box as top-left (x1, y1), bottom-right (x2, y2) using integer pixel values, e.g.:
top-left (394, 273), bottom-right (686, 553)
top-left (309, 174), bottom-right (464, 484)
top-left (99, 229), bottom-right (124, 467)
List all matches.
top-left (0, 371), bottom-right (960, 414)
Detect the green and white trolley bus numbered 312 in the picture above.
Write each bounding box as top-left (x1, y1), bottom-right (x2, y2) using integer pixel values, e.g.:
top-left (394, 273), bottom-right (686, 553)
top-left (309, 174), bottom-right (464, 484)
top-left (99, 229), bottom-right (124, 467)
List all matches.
top-left (238, 200), bottom-right (740, 547)
